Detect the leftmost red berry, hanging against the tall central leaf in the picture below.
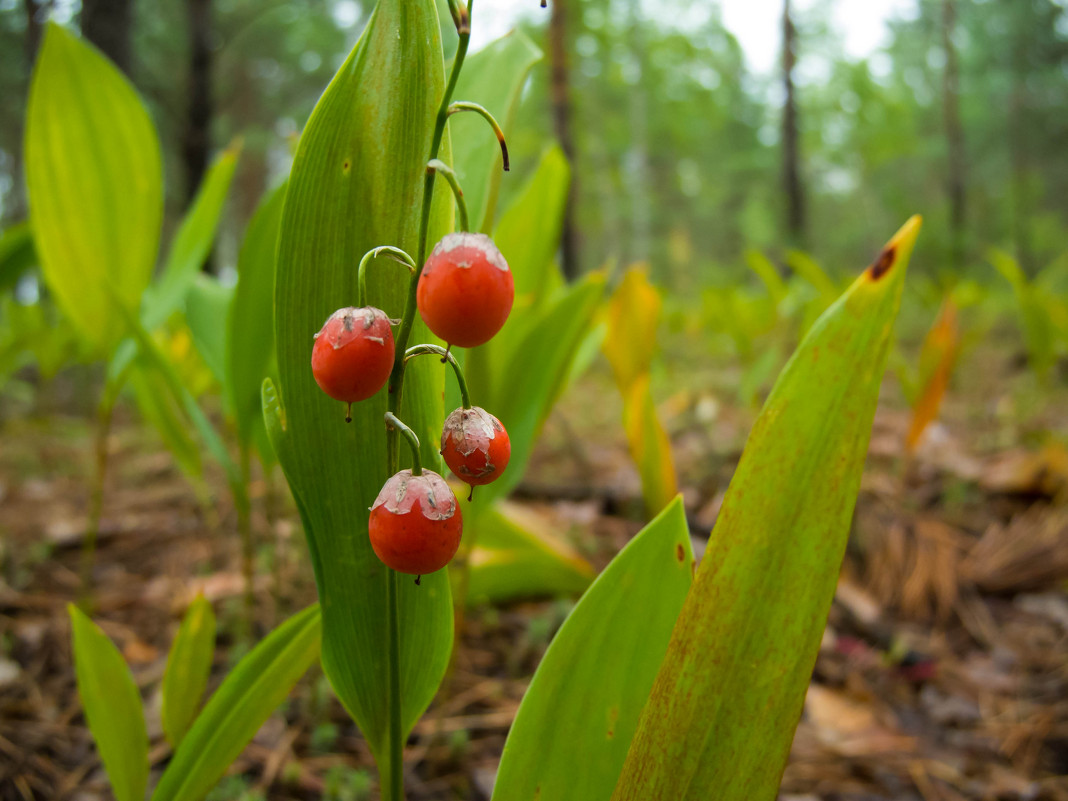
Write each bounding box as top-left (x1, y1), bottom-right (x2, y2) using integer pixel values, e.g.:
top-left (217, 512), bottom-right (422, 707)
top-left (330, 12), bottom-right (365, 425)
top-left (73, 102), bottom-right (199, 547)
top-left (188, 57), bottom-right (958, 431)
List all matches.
top-left (312, 307), bottom-right (394, 404)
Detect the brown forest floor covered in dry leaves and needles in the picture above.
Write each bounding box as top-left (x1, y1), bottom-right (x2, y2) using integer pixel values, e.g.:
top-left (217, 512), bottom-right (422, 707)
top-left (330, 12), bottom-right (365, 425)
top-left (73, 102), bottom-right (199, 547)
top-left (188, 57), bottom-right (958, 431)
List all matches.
top-left (0, 348), bottom-right (1068, 801)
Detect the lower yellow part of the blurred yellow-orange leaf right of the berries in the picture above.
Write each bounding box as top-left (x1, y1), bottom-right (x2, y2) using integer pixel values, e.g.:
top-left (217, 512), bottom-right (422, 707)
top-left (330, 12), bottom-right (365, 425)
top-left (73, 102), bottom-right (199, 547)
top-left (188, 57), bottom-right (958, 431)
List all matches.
top-left (623, 373), bottom-right (678, 517)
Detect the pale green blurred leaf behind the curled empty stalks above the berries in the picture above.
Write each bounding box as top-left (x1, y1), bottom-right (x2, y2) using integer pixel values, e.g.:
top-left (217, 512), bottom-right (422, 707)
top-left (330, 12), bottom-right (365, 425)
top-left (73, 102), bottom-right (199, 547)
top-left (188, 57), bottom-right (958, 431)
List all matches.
top-left (449, 31), bottom-right (542, 231)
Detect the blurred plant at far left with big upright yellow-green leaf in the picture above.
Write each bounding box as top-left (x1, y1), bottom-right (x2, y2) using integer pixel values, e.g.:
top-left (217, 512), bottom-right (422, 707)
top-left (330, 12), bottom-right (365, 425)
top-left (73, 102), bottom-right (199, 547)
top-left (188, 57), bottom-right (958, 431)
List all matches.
top-left (26, 23), bottom-right (244, 599)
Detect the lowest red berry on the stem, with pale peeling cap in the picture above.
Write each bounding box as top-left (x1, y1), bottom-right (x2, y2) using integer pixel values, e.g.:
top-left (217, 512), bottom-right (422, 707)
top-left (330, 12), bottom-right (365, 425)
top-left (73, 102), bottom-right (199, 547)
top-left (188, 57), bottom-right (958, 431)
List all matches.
top-left (367, 470), bottom-right (464, 576)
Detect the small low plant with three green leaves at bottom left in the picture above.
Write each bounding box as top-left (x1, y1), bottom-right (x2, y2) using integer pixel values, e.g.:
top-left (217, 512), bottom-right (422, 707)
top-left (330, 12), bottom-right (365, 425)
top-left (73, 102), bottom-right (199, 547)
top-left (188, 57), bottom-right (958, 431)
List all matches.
top-left (68, 598), bottom-right (319, 801)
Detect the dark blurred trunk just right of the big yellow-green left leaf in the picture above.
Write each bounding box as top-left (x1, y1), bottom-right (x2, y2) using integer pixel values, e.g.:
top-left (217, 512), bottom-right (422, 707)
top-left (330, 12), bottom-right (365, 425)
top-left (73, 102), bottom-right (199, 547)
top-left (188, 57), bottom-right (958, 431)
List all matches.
top-left (182, 0), bottom-right (213, 207)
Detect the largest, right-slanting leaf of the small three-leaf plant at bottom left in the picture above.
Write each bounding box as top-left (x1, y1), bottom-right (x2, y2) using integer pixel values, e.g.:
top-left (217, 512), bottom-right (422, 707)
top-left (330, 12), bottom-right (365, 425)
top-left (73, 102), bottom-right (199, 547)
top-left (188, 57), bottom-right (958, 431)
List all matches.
top-left (152, 603), bottom-right (321, 801)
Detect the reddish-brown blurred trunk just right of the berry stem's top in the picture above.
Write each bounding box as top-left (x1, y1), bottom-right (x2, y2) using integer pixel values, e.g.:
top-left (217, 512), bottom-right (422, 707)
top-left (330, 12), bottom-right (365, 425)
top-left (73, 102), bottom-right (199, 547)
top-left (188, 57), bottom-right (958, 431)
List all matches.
top-left (549, 0), bottom-right (579, 281)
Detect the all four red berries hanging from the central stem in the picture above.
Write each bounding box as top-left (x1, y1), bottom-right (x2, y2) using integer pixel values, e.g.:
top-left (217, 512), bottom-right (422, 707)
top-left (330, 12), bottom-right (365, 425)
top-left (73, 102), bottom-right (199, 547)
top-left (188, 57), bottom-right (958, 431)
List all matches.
top-left (312, 232), bottom-right (515, 576)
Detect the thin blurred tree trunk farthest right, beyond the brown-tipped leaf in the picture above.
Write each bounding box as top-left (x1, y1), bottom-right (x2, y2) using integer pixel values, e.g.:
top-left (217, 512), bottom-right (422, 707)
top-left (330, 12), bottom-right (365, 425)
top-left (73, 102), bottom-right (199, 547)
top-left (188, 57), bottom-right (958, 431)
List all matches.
top-left (942, 0), bottom-right (967, 274)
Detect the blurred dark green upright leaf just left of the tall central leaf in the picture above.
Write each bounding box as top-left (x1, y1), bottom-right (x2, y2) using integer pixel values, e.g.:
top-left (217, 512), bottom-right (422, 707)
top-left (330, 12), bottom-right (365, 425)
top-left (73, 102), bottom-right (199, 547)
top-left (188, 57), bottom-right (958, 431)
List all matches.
top-left (223, 184), bottom-right (285, 446)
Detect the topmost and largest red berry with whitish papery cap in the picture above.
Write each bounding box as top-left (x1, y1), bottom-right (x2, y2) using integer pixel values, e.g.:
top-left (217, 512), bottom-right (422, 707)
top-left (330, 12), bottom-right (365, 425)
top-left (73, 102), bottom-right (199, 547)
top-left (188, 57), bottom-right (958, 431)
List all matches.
top-left (417, 232), bottom-right (516, 348)
